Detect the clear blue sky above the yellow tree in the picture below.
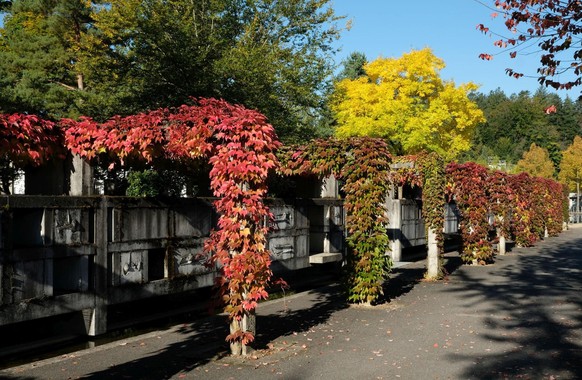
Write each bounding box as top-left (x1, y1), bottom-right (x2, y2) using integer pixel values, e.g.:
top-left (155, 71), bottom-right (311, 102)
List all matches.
top-left (333, 0), bottom-right (580, 99)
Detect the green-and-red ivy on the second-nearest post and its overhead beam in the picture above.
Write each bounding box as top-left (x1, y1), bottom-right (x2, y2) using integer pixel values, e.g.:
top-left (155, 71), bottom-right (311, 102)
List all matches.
top-left (279, 138), bottom-right (391, 303)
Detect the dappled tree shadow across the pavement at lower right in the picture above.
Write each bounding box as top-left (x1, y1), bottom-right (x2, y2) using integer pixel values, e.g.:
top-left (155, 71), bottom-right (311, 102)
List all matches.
top-left (450, 232), bottom-right (582, 379)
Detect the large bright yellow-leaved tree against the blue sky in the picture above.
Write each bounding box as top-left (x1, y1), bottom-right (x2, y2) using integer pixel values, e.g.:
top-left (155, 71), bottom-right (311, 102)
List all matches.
top-left (332, 48), bottom-right (485, 160)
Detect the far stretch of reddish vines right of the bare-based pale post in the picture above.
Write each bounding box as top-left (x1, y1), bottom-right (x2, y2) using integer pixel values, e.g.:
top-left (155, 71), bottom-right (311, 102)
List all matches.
top-left (447, 163), bottom-right (565, 262)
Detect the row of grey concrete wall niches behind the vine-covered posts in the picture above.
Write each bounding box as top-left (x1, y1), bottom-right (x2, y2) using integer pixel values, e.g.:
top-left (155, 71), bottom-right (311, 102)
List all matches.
top-left (0, 159), bottom-right (458, 336)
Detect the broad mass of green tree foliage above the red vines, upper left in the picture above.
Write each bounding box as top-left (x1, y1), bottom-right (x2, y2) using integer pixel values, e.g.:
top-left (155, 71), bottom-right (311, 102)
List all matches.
top-left (0, 0), bottom-right (340, 140)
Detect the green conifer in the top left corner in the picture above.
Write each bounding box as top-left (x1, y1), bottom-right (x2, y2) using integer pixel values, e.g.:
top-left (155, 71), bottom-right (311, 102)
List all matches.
top-left (0, 0), bottom-right (91, 117)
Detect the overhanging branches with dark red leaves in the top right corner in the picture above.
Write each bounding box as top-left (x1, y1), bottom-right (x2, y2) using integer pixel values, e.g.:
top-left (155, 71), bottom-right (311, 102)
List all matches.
top-left (477, 0), bottom-right (582, 89)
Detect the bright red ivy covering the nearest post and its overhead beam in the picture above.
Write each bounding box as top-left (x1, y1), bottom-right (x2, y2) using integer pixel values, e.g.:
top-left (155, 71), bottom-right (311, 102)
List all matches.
top-left (61, 99), bottom-right (280, 354)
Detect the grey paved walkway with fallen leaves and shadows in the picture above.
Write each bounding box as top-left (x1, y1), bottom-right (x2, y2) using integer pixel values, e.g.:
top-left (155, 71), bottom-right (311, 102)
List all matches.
top-left (0, 228), bottom-right (582, 380)
